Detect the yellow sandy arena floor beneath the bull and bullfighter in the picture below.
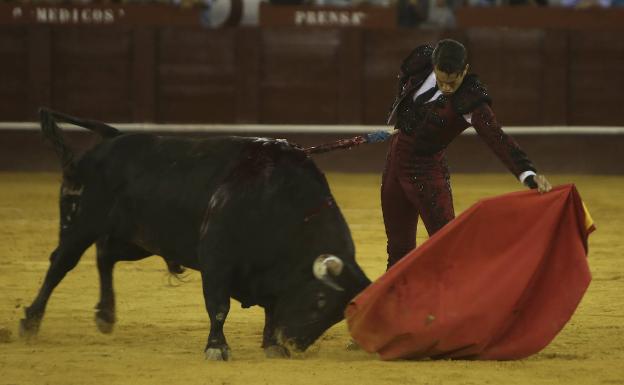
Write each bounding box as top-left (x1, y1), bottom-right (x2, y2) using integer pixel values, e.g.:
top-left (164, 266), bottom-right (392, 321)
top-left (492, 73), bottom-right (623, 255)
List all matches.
top-left (0, 173), bottom-right (624, 385)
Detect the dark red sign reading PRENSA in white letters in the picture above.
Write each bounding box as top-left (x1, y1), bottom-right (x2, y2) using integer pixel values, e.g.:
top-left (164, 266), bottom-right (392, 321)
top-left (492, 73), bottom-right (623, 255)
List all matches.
top-left (260, 2), bottom-right (397, 28)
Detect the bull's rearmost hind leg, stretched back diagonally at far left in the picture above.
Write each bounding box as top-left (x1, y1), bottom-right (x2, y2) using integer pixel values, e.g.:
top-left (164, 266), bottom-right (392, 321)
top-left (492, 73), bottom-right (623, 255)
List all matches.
top-left (19, 233), bottom-right (95, 338)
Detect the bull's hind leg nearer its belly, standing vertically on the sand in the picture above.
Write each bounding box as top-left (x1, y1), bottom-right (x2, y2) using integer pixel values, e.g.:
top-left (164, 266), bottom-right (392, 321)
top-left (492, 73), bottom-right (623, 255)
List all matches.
top-left (95, 236), bottom-right (152, 334)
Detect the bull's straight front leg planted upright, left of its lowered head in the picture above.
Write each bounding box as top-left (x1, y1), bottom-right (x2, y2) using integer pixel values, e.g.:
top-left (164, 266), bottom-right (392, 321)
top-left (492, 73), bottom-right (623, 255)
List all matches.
top-left (202, 270), bottom-right (231, 361)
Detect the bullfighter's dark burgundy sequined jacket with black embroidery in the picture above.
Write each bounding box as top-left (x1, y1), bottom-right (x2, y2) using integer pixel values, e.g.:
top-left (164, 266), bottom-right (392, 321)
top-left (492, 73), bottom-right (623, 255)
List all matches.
top-left (388, 45), bottom-right (535, 177)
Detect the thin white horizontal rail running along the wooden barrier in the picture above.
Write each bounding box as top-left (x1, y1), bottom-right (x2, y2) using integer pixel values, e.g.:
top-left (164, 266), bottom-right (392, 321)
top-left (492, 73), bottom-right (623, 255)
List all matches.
top-left (0, 122), bottom-right (624, 135)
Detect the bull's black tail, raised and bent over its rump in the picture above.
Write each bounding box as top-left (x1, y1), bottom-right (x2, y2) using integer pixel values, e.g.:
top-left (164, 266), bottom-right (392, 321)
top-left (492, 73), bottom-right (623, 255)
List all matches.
top-left (39, 108), bottom-right (121, 172)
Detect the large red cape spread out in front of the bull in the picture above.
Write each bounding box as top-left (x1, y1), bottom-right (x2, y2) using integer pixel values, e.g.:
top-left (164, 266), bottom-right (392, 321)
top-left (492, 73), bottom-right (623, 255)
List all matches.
top-left (346, 185), bottom-right (593, 360)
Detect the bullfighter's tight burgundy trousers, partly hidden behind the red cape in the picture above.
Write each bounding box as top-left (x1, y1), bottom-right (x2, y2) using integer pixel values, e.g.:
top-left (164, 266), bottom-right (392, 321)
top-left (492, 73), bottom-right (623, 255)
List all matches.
top-left (381, 133), bottom-right (455, 268)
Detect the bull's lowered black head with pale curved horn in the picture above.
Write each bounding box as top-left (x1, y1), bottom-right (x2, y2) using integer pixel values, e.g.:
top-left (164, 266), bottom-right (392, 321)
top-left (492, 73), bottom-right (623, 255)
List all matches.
top-left (274, 254), bottom-right (370, 351)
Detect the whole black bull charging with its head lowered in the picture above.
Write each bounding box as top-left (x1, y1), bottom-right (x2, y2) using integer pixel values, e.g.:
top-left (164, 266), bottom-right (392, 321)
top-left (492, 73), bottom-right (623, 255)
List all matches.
top-left (20, 109), bottom-right (370, 360)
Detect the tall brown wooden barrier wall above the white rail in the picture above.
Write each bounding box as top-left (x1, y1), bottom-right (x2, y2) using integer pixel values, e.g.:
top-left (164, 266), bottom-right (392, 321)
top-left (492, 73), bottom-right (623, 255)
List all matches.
top-left (0, 25), bottom-right (624, 126)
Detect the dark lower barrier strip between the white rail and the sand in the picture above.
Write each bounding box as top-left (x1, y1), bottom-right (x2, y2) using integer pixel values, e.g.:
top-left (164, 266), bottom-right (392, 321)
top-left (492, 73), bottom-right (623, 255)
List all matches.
top-left (0, 127), bottom-right (624, 172)
